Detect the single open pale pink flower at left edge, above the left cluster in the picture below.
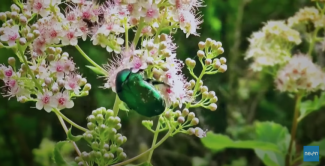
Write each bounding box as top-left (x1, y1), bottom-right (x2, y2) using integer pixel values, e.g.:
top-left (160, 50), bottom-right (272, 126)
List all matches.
top-left (0, 25), bottom-right (20, 46)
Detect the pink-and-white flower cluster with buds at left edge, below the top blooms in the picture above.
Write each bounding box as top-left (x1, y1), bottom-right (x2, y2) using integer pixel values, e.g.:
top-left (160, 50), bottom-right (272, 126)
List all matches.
top-left (0, 47), bottom-right (91, 112)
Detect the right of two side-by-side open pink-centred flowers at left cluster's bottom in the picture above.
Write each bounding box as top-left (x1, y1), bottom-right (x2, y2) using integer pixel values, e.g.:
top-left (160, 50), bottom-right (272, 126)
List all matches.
top-left (53, 91), bottom-right (74, 110)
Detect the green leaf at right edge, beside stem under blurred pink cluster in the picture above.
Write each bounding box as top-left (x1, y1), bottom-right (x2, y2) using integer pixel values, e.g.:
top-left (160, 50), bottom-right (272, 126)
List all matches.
top-left (298, 92), bottom-right (325, 121)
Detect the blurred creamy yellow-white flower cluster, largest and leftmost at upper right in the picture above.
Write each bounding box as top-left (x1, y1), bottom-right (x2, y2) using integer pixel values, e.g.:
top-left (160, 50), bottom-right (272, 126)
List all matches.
top-left (245, 21), bottom-right (301, 71)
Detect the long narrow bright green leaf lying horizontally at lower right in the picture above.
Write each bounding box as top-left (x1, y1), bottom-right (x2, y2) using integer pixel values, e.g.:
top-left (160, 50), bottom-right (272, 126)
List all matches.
top-left (201, 132), bottom-right (280, 153)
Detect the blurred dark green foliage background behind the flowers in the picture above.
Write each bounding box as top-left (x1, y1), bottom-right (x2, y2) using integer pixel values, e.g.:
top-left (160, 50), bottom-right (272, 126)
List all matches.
top-left (0, 0), bottom-right (325, 166)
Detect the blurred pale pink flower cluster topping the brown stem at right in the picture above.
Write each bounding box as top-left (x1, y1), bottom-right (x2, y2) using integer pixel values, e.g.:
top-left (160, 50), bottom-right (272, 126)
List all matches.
top-left (275, 54), bottom-right (325, 92)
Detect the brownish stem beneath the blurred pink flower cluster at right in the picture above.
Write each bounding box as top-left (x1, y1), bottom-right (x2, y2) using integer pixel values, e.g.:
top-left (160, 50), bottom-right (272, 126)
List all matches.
top-left (286, 94), bottom-right (303, 166)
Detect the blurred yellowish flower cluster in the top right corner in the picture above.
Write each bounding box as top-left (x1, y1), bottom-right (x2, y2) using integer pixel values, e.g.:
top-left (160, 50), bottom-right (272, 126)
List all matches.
top-left (288, 7), bottom-right (325, 28)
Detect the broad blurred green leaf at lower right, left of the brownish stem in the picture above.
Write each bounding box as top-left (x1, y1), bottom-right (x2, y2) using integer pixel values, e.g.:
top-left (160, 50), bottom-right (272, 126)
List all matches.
top-left (255, 122), bottom-right (294, 166)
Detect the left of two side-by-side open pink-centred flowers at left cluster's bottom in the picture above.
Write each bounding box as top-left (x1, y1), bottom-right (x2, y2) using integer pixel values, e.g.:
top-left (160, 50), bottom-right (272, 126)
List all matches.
top-left (36, 91), bottom-right (54, 112)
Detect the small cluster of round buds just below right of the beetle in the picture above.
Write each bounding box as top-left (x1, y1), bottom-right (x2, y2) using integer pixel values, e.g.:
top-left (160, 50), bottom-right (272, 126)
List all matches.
top-left (160, 108), bottom-right (206, 138)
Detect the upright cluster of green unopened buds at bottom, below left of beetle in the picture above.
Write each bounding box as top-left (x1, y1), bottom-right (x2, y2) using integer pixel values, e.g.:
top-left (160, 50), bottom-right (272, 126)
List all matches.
top-left (75, 108), bottom-right (127, 165)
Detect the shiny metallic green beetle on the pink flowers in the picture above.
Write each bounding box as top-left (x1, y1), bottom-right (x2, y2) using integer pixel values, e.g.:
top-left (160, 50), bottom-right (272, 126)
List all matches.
top-left (115, 69), bottom-right (169, 117)
